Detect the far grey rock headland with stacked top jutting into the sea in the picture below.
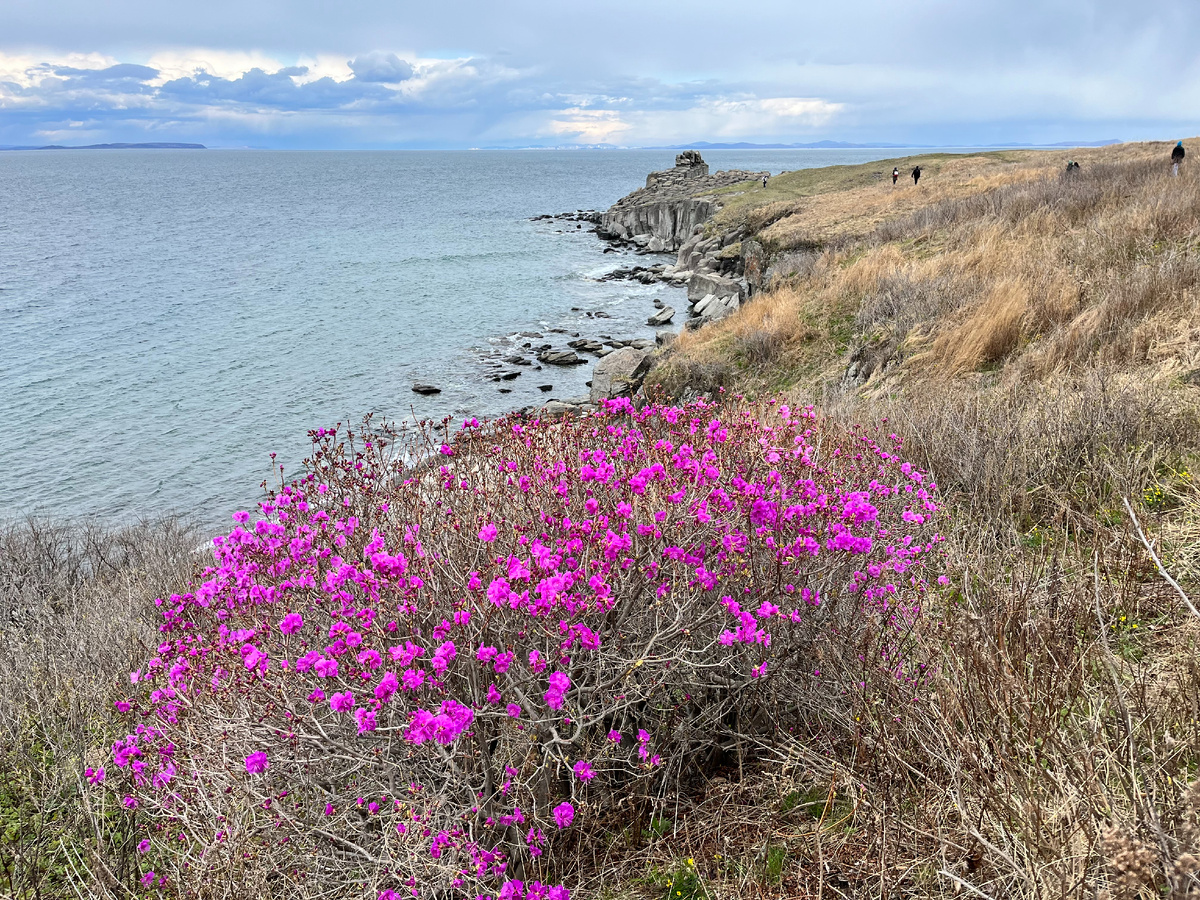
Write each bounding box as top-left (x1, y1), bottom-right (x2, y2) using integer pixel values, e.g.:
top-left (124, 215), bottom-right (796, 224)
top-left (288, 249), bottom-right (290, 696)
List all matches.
top-left (596, 150), bottom-right (766, 252)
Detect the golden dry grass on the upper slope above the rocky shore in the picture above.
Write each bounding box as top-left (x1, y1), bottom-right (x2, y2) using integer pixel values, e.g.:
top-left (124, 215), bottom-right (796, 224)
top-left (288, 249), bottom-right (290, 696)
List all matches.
top-left (677, 136), bottom-right (1200, 398)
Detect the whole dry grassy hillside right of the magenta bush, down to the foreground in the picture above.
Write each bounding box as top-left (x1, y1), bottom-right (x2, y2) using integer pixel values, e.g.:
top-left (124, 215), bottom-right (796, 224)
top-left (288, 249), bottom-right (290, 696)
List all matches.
top-left (633, 144), bottom-right (1200, 900)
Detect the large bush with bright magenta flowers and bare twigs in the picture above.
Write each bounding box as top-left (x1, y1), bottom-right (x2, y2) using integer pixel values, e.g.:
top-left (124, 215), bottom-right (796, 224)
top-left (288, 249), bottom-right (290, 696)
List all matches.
top-left (106, 401), bottom-right (940, 900)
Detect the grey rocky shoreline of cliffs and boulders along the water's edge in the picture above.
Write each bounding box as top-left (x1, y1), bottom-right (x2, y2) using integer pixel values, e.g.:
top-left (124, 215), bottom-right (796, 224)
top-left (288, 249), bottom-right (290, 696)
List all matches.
top-left (413, 150), bottom-right (767, 415)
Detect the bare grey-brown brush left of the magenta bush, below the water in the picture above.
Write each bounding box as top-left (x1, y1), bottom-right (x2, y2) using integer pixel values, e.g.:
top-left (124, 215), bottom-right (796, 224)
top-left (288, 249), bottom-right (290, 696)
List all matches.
top-left (0, 518), bottom-right (198, 898)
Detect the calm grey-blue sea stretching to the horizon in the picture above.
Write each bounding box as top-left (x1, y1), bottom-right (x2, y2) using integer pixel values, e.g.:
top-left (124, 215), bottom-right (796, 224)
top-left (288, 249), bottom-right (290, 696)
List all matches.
top-left (0, 150), bottom-right (926, 528)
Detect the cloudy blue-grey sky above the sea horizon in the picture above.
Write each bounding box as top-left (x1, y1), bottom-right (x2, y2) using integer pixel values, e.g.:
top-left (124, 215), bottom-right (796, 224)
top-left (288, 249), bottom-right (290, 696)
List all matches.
top-left (0, 0), bottom-right (1200, 149)
